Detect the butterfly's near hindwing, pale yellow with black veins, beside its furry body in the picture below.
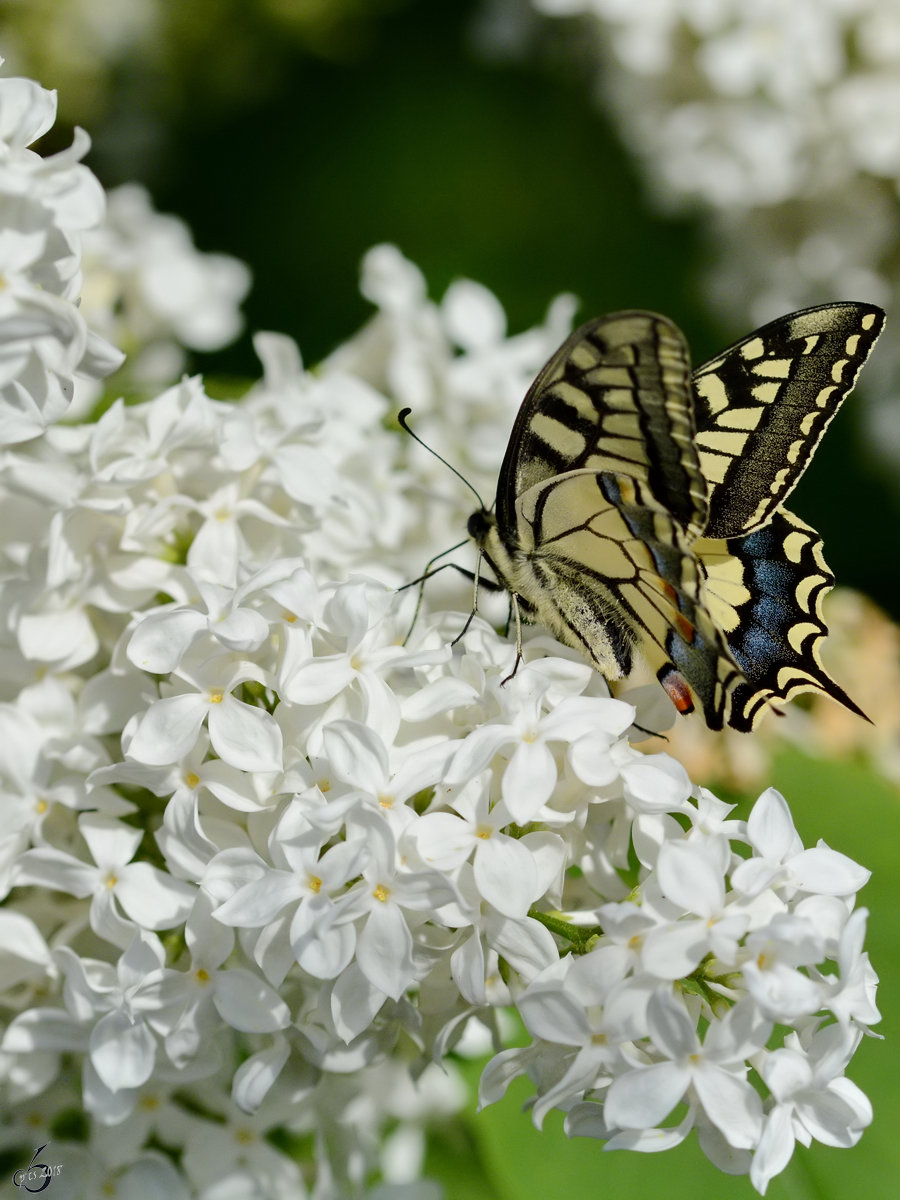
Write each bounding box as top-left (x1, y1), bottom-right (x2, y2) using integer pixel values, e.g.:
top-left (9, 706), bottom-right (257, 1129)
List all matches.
top-left (513, 470), bottom-right (738, 727)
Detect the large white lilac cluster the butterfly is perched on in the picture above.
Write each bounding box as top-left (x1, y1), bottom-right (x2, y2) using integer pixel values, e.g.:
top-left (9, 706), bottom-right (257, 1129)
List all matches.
top-left (0, 68), bottom-right (878, 1200)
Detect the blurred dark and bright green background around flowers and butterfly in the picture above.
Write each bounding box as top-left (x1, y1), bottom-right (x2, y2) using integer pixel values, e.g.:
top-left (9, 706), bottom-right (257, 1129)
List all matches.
top-left (0, 0), bottom-right (900, 1200)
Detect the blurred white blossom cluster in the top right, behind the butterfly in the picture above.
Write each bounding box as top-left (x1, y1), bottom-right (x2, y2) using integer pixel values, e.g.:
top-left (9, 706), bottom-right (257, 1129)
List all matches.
top-left (520, 0), bottom-right (900, 462)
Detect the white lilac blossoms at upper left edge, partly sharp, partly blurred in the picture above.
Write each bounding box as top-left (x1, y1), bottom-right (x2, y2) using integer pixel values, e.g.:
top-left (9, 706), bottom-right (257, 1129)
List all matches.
top-left (0, 69), bottom-right (250, 432)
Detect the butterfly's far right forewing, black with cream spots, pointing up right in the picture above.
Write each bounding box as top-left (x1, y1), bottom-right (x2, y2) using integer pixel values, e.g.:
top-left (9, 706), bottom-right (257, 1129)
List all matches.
top-left (694, 301), bottom-right (884, 538)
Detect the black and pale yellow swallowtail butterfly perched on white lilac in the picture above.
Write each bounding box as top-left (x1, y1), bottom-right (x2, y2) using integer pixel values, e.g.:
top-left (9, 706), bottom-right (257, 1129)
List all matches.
top-left (468, 301), bottom-right (884, 731)
